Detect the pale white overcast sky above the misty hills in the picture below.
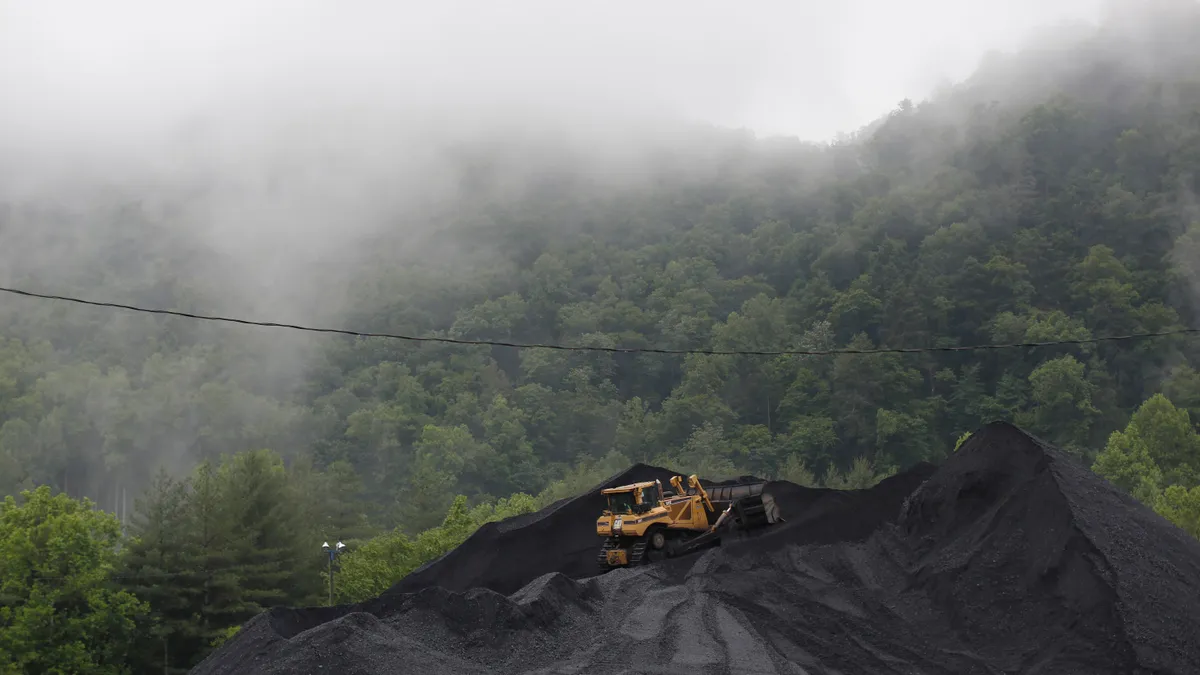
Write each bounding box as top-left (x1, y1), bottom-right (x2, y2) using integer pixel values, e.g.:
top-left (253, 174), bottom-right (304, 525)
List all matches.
top-left (0, 0), bottom-right (1100, 147)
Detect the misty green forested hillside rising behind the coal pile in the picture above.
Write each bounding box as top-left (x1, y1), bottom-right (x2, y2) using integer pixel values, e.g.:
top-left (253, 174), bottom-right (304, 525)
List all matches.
top-left (7, 2), bottom-right (1200, 670)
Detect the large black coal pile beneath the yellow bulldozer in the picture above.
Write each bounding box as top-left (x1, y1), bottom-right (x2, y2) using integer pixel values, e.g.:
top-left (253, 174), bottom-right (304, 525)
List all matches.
top-left (187, 423), bottom-right (1200, 675)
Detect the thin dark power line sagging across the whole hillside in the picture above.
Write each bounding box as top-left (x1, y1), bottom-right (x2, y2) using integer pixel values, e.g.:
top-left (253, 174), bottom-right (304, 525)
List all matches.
top-left (0, 286), bottom-right (1200, 357)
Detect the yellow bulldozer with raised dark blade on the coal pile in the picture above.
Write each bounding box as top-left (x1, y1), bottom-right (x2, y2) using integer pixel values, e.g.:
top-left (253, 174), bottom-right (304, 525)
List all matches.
top-left (596, 474), bottom-right (784, 571)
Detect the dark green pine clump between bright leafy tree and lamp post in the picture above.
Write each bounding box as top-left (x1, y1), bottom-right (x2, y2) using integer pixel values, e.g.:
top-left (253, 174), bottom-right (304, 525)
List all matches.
top-left (122, 450), bottom-right (343, 671)
